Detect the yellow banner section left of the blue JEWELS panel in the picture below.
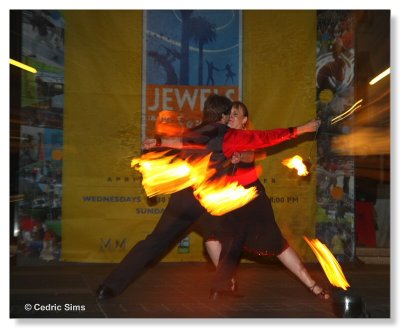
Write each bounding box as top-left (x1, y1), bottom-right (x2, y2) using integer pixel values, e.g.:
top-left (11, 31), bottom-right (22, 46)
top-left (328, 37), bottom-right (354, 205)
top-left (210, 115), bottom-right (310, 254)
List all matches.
top-left (61, 11), bottom-right (203, 262)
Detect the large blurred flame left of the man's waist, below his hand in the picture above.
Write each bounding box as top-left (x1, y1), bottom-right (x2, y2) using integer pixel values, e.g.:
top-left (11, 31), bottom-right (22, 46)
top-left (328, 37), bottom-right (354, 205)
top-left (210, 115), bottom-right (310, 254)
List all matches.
top-left (131, 151), bottom-right (211, 197)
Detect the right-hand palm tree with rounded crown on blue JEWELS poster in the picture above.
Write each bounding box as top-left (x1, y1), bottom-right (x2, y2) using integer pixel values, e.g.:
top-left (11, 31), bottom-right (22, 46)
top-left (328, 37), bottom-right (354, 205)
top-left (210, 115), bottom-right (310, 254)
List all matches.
top-left (190, 16), bottom-right (217, 85)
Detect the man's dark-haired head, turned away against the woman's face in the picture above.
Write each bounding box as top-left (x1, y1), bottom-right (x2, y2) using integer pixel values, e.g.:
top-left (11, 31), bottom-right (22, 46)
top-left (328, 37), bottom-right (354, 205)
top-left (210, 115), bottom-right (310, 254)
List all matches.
top-left (203, 95), bottom-right (232, 123)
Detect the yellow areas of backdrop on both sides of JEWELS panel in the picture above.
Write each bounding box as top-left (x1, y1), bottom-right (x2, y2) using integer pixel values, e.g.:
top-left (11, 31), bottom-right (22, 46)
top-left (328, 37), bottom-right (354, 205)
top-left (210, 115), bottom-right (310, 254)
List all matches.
top-left (62, 10), bottom-right (316, 262)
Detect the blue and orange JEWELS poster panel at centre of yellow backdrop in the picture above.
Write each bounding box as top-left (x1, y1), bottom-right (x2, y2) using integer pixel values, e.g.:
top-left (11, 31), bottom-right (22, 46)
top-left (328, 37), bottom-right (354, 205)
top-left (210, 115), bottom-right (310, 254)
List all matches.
top-left (142, 10), bottom-right (242, 139)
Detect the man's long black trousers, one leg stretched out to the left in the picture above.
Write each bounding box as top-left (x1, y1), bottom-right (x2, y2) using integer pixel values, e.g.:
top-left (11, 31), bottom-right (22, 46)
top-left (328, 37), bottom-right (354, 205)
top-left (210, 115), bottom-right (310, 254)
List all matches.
top-left (104, 188), bottom-right (240, 293)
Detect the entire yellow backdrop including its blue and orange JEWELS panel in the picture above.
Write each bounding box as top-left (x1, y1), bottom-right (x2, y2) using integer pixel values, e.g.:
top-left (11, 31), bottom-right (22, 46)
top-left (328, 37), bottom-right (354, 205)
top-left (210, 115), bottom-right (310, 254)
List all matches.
top-left (61, 11), bottom-right (316, 262)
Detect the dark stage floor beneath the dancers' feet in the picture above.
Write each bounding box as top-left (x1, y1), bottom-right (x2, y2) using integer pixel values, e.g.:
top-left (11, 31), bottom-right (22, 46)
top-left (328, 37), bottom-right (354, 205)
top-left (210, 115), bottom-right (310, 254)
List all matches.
top-left (10, 263), bottom-right (391, 318)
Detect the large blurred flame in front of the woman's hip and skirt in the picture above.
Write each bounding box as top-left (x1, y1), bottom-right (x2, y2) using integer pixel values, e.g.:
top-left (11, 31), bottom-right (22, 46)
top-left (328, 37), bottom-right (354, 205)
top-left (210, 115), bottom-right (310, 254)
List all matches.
top-left (194, 180), bottom-right (258, 216)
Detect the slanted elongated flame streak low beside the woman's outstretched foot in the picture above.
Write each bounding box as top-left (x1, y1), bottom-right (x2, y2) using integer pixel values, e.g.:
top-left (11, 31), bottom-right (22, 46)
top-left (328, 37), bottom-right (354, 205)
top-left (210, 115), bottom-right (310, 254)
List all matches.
top-left (304, 236), bottom-right (350, 290)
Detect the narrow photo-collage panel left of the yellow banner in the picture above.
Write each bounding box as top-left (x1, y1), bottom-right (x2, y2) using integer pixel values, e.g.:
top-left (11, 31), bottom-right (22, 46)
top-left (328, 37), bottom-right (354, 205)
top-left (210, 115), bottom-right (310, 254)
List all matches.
top-left (14, 10), bottom-right (64, 261)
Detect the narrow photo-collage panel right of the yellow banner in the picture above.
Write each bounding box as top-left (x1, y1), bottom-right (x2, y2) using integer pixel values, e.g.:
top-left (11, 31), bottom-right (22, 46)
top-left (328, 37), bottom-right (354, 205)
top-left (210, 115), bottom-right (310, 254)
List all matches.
top-left (316, 10), bottom-right (355, 262)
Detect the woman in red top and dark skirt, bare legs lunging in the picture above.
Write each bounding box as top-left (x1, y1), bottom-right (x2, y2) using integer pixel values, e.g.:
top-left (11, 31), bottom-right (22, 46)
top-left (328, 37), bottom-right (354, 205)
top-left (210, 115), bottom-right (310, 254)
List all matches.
top-left (194, 101), bottom-right (330, 300)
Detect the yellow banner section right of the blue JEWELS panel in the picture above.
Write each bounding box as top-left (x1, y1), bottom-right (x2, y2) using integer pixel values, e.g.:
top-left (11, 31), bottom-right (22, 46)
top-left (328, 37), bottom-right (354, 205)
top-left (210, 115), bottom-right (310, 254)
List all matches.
top-left (243, 10), bottom-right (316, 261)
